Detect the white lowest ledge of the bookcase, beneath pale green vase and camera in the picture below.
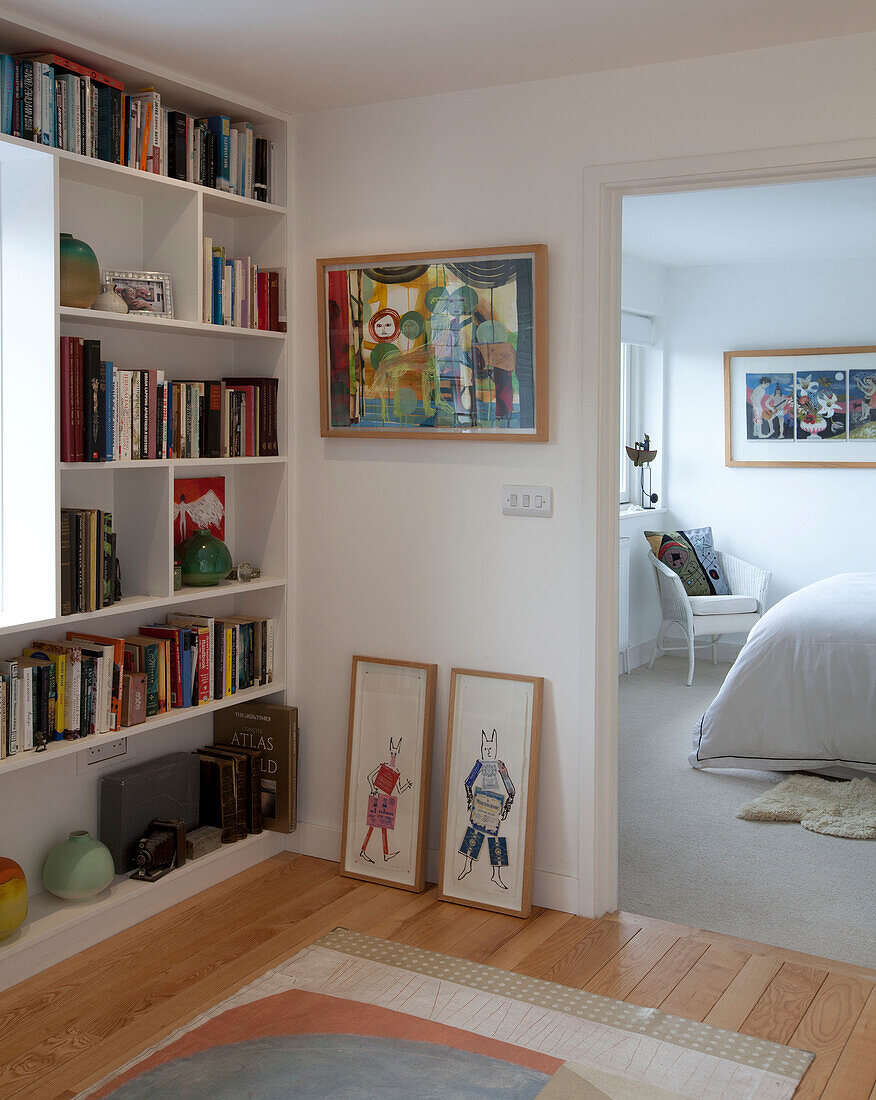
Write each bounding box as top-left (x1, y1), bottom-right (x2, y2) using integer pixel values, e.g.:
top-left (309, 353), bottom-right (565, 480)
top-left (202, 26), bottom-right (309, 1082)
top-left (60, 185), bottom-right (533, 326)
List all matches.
top-left (0, 831), bottom-right (286, 989)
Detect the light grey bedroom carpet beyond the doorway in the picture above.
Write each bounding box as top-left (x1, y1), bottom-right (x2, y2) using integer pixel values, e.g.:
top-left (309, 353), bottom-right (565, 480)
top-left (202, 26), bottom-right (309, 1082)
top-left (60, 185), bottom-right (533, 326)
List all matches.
top-left (618, 657), bottom-right (876, 966)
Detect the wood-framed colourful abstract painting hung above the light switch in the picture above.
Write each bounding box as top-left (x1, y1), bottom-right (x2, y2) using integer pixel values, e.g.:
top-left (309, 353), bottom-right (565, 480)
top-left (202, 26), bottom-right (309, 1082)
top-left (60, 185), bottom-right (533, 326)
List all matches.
top-left (317, 244), bottom-right (548, 442)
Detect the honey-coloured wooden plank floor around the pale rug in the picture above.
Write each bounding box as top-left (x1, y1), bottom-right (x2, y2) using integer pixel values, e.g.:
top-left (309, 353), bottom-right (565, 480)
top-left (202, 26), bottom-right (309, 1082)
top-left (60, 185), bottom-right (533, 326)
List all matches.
top-left (0, 855), bottom-right (876, 1100)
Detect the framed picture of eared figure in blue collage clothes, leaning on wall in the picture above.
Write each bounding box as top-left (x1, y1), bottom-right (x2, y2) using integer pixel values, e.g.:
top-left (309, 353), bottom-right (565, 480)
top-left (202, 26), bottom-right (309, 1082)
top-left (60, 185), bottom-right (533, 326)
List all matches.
top-left (438, 669), bottom-right (545, 917)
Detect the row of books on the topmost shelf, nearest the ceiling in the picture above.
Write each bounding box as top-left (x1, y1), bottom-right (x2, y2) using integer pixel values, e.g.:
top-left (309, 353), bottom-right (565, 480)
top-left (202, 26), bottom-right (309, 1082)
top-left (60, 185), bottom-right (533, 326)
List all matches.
top-left (0, 54), bottom-right (276, 202)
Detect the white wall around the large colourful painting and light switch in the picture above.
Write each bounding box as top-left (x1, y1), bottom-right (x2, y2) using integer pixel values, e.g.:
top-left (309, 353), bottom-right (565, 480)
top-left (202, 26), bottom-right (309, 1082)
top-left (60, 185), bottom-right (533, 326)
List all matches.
top-left (293, 34), bottom-right (876, 909)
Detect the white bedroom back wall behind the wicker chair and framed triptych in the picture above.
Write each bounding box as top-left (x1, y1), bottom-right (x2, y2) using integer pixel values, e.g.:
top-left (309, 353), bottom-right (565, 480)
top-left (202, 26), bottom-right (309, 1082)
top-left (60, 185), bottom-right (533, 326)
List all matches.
top-left (666, 260), bottom-right (876, 604)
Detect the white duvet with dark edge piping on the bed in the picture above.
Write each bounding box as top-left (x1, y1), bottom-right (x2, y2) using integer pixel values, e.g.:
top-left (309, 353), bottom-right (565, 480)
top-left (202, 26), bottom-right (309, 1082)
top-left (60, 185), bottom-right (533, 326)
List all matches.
top-left (689, 573), bottom-right (876, 771)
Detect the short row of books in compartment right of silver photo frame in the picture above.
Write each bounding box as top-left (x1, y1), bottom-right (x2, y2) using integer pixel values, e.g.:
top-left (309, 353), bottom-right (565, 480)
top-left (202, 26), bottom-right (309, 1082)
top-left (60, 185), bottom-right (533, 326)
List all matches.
top-left (202, 246), bottom-right (286, 332)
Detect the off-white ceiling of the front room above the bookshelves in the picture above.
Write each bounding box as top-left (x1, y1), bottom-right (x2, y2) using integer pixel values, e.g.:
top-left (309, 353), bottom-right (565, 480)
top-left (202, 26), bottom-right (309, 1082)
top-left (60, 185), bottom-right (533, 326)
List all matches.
top-left (4, 0), bottom-right (876, 113)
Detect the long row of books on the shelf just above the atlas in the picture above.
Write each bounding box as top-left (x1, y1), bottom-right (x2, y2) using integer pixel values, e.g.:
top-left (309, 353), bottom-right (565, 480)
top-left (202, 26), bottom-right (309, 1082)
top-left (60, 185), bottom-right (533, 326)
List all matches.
top-left (0, 615), bottom-right (274, 757)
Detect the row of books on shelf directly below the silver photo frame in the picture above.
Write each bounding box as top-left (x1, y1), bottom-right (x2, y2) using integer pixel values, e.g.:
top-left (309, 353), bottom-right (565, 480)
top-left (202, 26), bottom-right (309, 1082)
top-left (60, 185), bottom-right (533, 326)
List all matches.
top-left (61, 337), bottom-right (278, 462)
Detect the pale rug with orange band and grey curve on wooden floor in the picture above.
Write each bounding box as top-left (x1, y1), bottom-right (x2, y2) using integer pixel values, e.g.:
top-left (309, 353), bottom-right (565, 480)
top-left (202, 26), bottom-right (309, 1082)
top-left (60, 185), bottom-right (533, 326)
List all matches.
top-left (81, 928), bottom-right (812, 1100)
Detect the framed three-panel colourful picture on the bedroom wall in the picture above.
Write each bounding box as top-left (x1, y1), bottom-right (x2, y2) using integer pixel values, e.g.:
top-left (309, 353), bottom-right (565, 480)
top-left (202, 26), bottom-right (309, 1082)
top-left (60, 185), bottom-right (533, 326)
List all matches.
top-left (724, 347), bottom-right (876, 468)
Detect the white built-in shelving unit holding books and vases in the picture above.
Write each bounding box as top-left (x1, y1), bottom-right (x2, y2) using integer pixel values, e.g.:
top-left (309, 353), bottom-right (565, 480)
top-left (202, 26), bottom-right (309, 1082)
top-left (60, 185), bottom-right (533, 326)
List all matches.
top-left (0, 18), bottom-right (291, 988)
